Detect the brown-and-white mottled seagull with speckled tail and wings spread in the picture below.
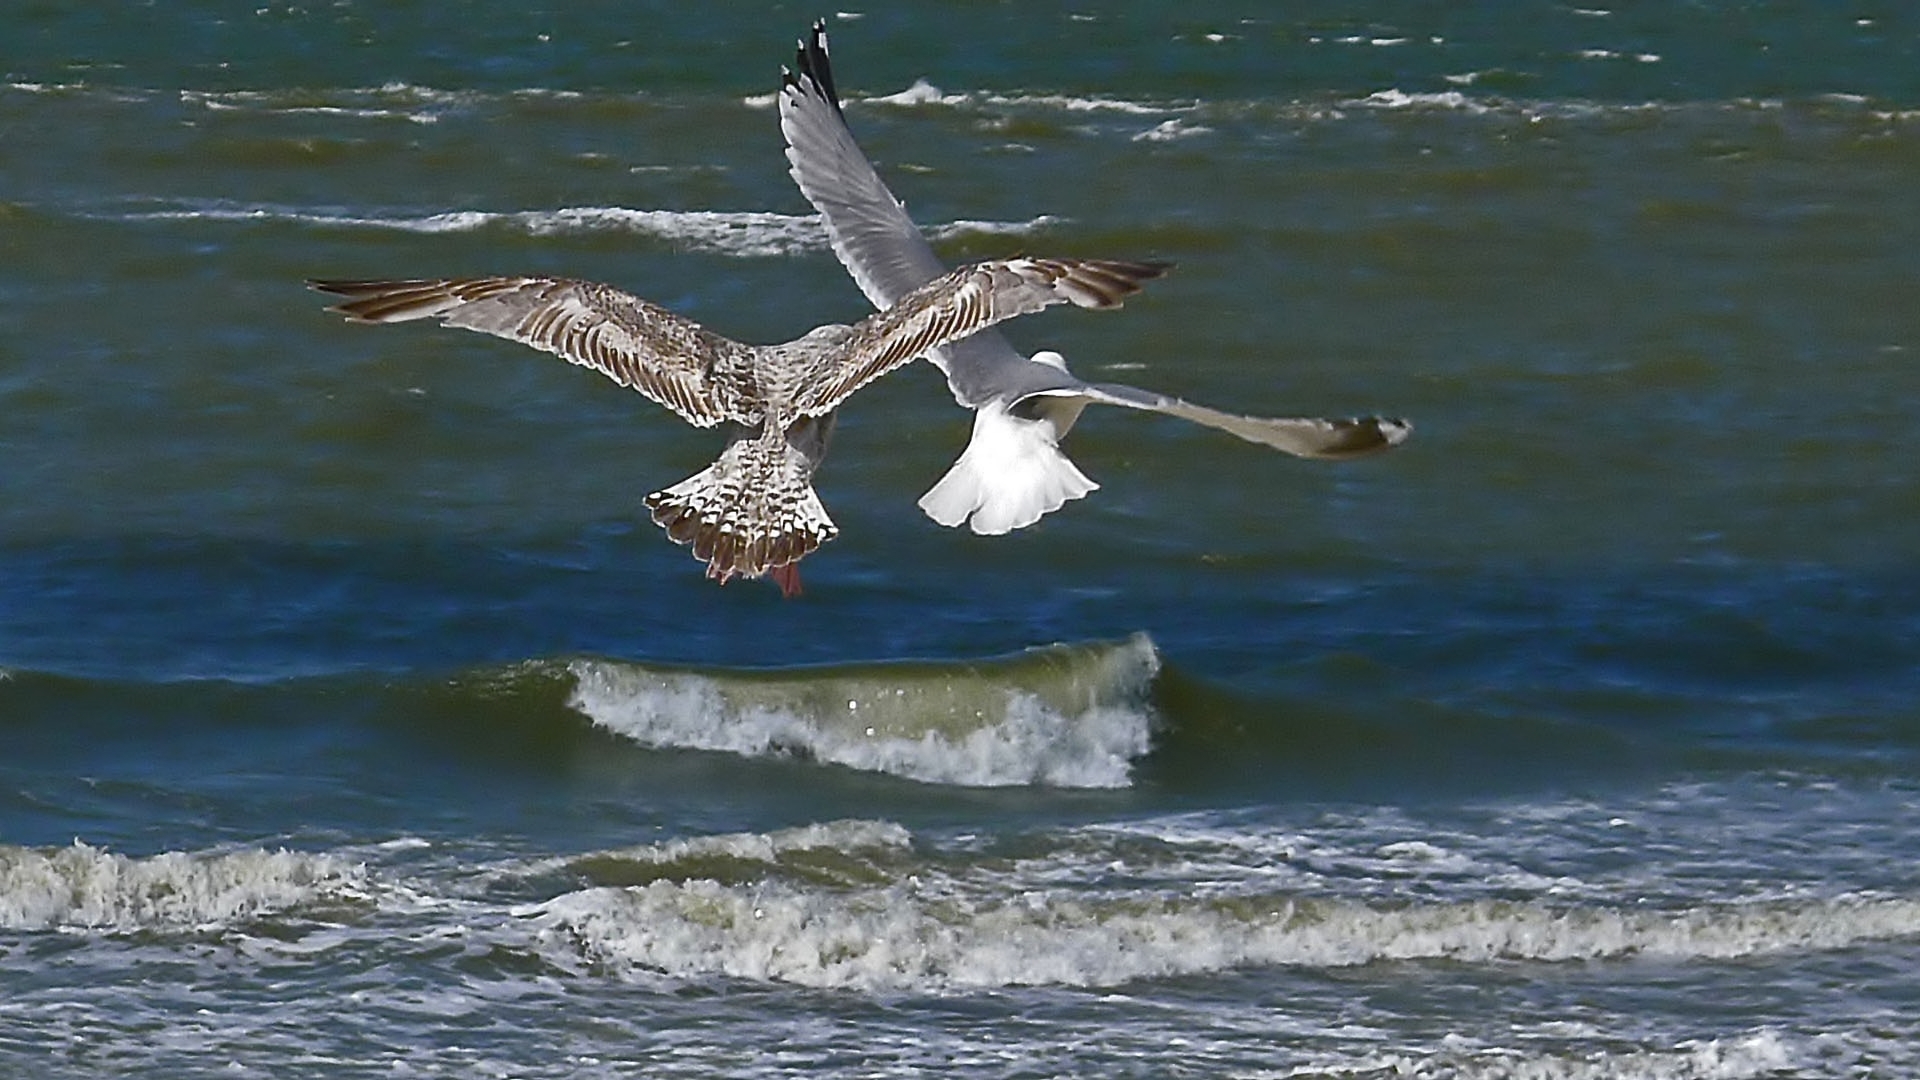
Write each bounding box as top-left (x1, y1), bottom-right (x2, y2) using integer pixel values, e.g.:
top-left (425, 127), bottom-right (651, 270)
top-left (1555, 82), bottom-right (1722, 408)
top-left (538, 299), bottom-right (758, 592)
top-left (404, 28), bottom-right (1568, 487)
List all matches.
top-left (307, 258), bottom-right (1167, 596)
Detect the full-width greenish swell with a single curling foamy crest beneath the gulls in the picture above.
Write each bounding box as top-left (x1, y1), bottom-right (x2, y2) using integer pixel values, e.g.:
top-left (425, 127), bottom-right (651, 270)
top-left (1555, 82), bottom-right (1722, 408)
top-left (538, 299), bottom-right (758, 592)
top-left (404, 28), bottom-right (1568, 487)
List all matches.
top-left (0, 611), bottom-right (1920, 798)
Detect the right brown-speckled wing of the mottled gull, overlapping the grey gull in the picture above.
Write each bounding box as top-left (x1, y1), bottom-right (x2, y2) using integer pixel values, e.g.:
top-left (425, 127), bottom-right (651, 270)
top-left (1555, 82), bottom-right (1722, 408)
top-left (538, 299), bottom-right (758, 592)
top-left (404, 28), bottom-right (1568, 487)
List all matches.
top-left (795, 258), bottom-right (1167, 415)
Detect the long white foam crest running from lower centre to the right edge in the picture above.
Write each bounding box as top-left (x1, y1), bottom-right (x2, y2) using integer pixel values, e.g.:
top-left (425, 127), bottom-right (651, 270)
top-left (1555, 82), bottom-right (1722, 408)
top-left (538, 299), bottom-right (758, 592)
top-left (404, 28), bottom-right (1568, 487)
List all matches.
top-left (540, 880), bottom-right (1920, 992)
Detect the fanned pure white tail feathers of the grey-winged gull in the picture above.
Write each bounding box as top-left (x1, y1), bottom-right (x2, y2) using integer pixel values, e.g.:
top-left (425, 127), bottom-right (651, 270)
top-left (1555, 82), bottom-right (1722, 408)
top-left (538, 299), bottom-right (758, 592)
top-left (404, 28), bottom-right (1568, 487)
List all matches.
top-left (920, 402), bottom-right (1100, 536)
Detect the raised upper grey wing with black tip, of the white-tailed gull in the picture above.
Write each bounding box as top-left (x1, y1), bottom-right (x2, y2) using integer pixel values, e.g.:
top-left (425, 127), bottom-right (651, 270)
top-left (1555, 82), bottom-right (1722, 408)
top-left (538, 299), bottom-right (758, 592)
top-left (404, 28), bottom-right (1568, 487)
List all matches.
top-left (780, 23), bottom-right (1044, 407)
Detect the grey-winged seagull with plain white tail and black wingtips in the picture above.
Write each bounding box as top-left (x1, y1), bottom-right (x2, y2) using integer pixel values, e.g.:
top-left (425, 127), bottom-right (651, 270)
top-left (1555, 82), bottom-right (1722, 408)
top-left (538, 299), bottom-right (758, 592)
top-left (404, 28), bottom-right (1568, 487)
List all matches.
top-left (780, 21), bottom-right (1413, 536)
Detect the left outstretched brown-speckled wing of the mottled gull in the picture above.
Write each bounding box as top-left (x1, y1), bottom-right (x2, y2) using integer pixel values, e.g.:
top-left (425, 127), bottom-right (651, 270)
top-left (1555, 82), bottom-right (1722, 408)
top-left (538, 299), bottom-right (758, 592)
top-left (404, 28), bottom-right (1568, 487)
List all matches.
top-left (307, 277), bottom-right (747, 427)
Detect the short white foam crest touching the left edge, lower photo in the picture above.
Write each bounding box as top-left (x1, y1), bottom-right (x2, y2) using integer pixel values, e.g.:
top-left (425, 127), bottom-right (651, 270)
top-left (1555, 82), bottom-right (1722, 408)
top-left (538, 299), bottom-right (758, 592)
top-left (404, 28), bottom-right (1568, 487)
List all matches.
top-left (0, 842), bottom-right (365, 930)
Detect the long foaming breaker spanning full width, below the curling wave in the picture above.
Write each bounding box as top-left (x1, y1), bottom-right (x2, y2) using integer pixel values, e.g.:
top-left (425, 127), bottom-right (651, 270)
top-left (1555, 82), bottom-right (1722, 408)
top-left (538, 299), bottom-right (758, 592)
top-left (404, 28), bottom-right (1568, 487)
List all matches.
top-left (15, 819), bottom-right (1920, 994)
